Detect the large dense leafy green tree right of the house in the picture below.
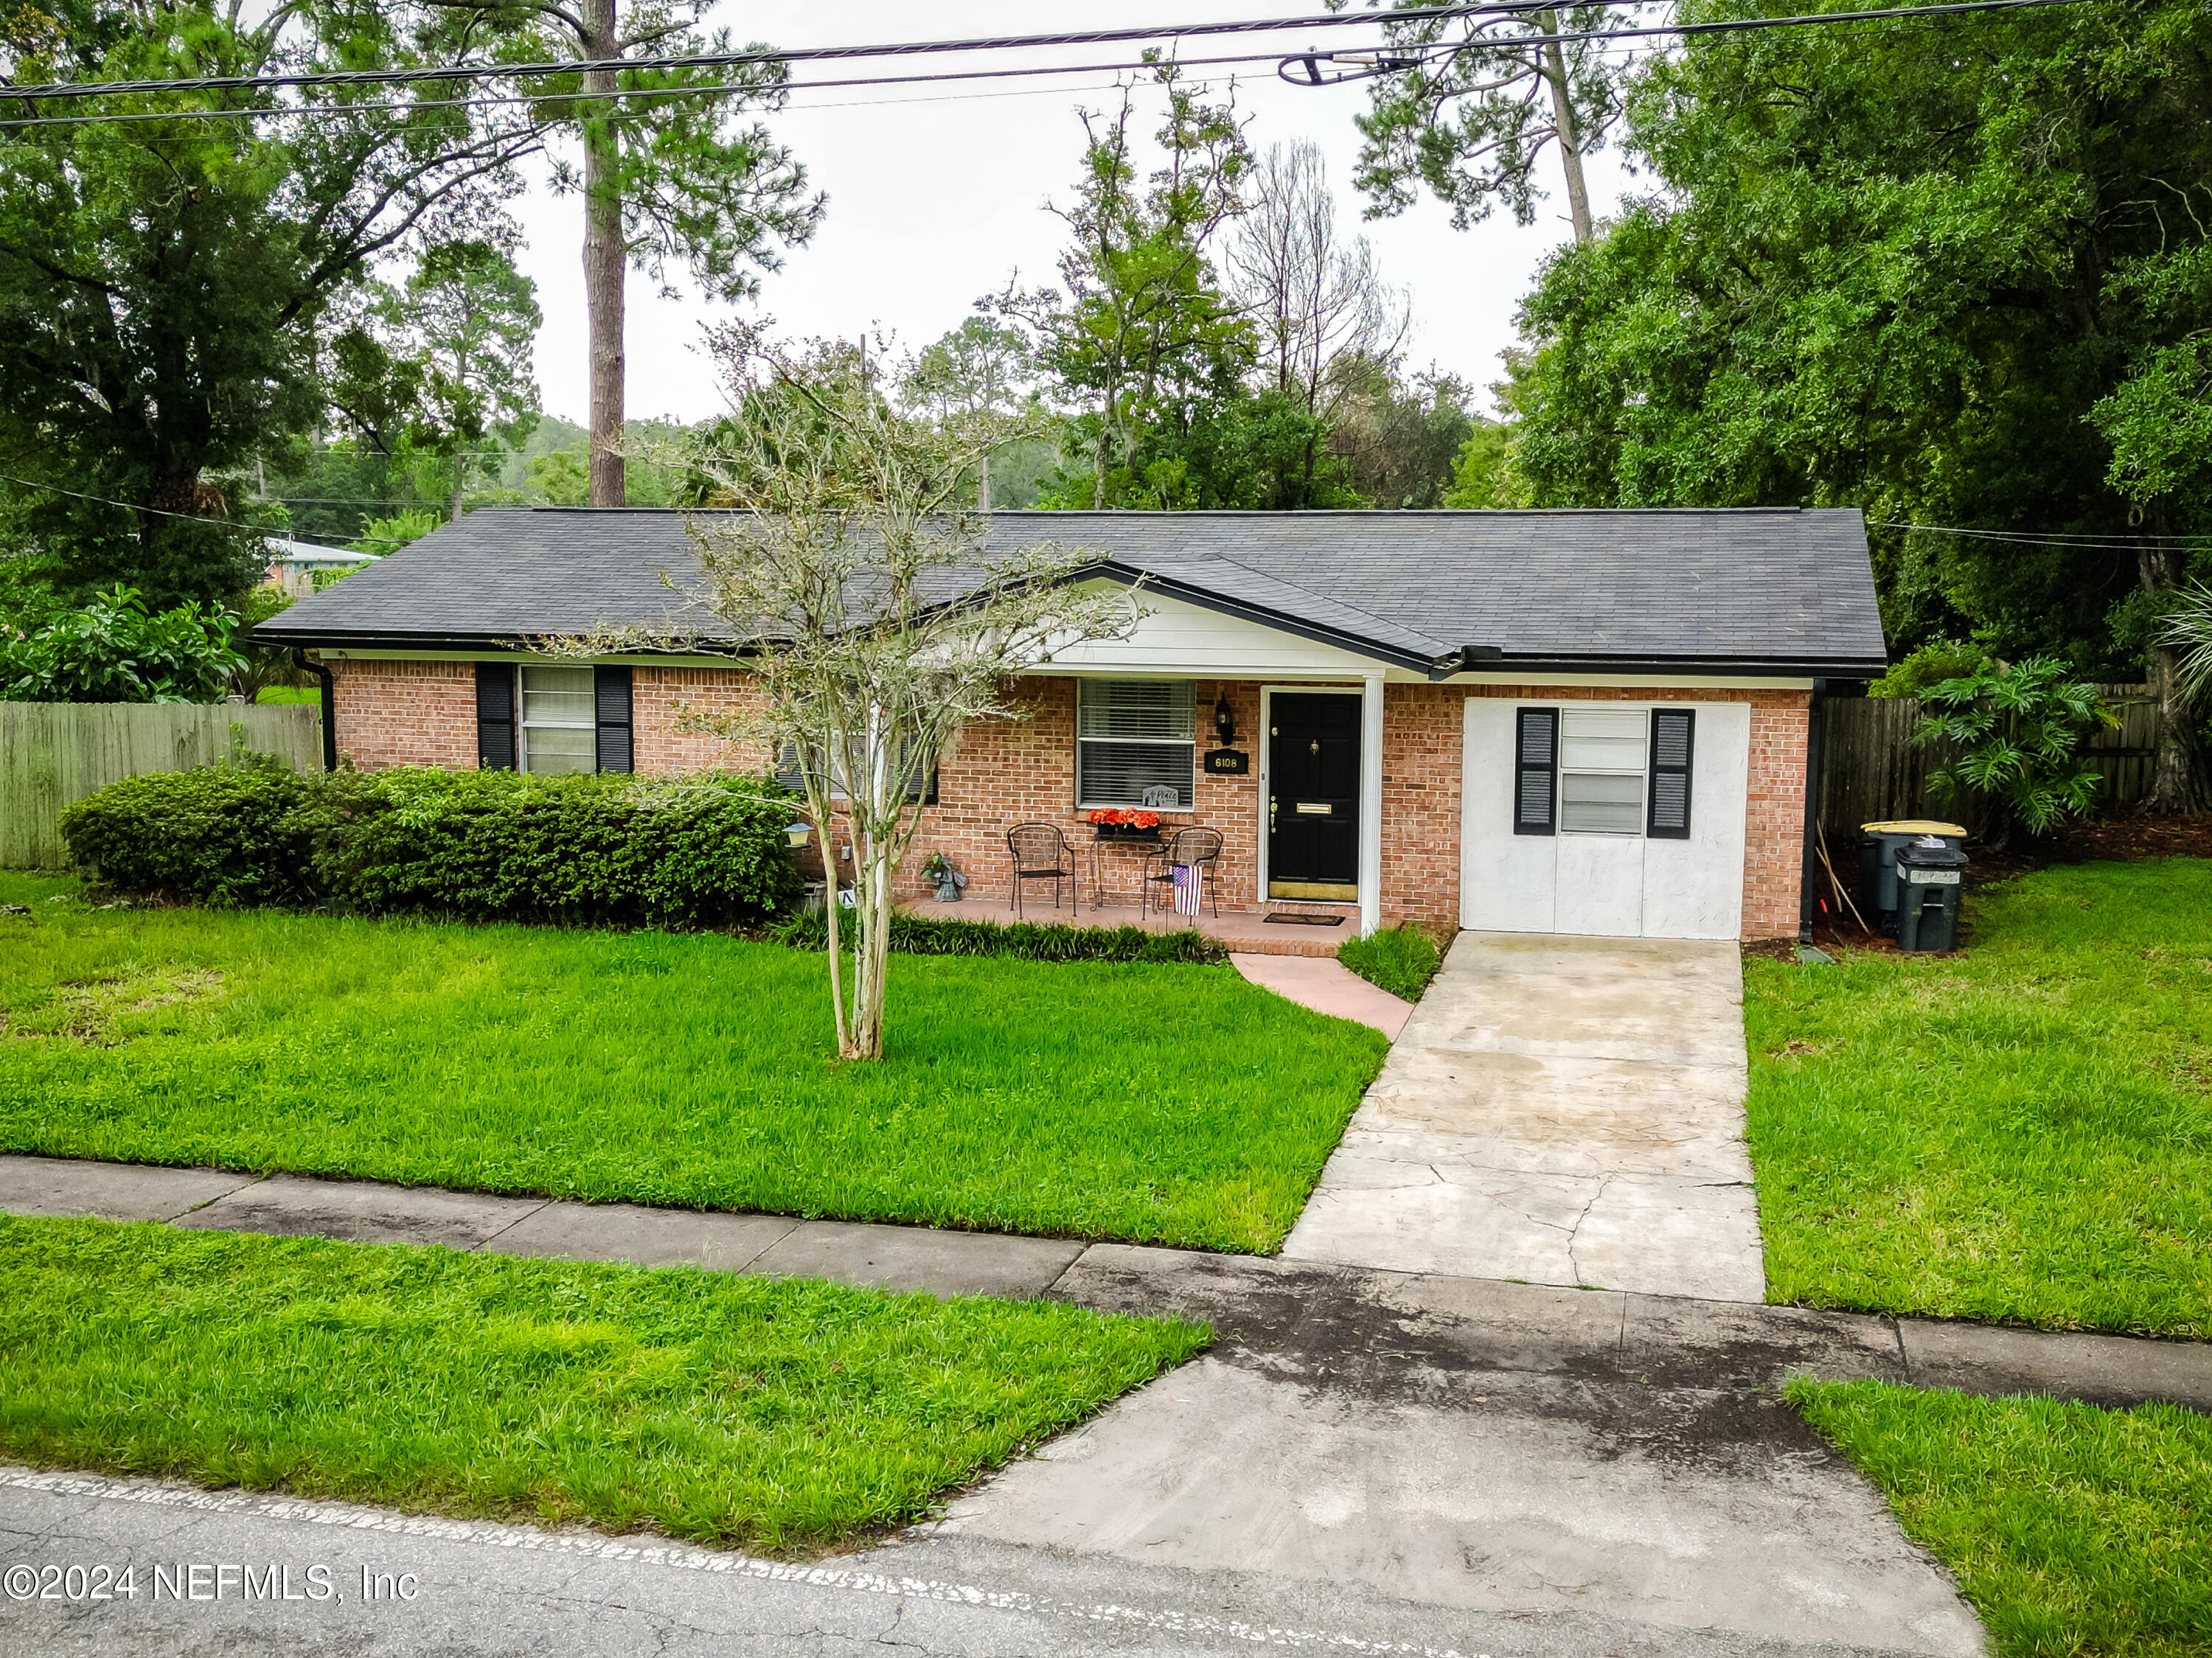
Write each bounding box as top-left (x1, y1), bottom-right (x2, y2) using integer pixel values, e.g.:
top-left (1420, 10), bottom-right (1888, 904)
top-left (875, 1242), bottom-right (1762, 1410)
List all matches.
top-left (1511, 0), bottom-right (2212, 812)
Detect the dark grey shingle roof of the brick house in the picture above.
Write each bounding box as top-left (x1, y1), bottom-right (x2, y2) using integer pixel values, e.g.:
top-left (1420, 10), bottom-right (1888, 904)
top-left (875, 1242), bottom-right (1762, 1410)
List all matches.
top-left (254, 506), bottom-right (1885, 679)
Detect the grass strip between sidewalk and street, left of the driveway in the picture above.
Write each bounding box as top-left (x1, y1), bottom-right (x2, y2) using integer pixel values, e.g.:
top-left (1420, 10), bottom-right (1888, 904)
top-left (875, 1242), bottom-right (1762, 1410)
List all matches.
top-left (0, 1216), bottom-right (1206, 1550)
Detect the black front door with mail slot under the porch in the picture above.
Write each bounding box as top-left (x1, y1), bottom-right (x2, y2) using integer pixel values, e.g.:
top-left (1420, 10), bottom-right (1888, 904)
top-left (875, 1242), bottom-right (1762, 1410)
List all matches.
top-left (1267, 692), bottom-right (1360, 904)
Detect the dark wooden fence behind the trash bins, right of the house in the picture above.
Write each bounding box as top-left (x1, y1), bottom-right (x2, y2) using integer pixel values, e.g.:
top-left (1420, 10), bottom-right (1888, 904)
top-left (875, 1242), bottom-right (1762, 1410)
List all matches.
top-left (1820, 686), bottom-right (2159, 851)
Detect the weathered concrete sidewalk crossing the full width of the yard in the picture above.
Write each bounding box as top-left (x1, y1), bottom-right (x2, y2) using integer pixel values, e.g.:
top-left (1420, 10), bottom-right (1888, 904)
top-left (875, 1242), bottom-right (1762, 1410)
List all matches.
top-left (0, 1156), bottom-right (2212, 1410)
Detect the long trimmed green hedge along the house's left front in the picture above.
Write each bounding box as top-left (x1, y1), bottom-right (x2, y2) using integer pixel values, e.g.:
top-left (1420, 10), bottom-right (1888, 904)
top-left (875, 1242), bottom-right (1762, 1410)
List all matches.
top-left (62, 763), bottom-right (799, 926)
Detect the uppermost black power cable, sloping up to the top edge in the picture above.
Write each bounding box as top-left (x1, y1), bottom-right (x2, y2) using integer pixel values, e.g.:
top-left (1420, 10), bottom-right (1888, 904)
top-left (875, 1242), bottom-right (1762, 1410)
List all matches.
top-left (0, 0), bottom-right (1522, 100)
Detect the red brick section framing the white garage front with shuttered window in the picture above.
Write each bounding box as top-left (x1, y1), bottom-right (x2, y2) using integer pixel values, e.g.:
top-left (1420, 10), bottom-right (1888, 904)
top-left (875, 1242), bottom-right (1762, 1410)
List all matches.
top-left (1382, 686), bottom-right (1812, 939)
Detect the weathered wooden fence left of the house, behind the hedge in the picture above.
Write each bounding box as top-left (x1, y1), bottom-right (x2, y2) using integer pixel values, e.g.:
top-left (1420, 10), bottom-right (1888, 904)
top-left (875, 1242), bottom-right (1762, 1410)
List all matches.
top-left (0, 703), bottom-right (323, 868)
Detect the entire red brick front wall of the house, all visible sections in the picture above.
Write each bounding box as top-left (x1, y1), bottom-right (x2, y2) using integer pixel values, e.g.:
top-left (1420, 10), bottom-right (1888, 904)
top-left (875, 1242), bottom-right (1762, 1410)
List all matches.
top-left (332, 661), bottom-right (1812, 939)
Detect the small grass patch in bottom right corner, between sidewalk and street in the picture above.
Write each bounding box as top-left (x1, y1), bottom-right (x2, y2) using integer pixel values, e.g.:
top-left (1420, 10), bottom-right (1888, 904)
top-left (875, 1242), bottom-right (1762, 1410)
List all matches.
top-left (1790, 1382), bottom-right (2212, 1658)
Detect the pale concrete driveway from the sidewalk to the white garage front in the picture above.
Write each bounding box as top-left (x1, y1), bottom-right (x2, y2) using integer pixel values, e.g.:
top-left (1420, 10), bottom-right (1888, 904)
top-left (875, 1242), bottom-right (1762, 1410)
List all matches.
top-left (1283, 933), bottom-right (1765, 1302)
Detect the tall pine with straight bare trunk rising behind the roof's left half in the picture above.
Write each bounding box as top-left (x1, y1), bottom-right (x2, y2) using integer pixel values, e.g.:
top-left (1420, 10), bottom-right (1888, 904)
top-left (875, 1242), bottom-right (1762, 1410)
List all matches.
top-left (422, 0), bottom-right (823, 506)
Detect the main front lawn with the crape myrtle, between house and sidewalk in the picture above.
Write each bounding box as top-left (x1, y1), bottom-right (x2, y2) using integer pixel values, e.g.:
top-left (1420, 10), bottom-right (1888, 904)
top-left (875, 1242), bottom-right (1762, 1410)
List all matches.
top-left (0, 875), bottom-right (1385, 1251)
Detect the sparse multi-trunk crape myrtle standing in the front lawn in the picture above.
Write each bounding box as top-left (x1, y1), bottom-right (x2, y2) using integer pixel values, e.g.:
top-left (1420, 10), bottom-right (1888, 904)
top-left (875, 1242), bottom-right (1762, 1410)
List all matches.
top-left (619, 327), bottom-right (1139, 1059)
